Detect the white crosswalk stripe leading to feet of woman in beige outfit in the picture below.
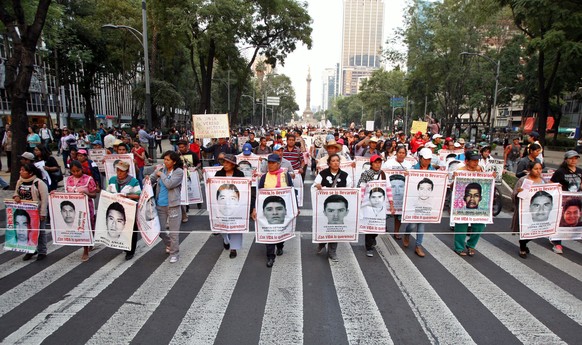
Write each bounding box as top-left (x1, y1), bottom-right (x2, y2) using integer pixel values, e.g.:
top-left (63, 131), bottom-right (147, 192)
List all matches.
top-left (87, 233), bottom-right (209, 344)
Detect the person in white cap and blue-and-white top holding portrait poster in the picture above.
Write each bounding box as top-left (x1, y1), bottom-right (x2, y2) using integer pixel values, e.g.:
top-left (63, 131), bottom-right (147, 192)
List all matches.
top-left (107, 160), bottom-right (141, 260)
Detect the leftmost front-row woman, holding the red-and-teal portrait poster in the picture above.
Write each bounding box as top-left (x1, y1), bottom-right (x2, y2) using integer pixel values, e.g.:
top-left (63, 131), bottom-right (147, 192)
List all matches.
top-left (12, 163), bottom-right (48, 261)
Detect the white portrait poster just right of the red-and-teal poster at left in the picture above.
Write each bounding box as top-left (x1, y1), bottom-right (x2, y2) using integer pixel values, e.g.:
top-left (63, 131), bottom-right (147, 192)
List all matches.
top-left (48, 192), bottom-right (93, 246)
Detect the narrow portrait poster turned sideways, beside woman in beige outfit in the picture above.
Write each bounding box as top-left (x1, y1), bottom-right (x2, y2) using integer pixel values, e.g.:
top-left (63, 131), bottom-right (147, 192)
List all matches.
top-left (137, 179), bottom-right (161, 246)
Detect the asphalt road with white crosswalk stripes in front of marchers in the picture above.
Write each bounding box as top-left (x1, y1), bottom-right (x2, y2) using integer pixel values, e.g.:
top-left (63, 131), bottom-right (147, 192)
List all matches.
top-left (0, 177), bottom-right (582, 345)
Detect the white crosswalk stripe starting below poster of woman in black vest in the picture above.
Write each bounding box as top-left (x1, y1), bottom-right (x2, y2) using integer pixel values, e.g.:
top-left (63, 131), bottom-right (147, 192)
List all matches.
top-left (330, 243), bottom-right (393, 344)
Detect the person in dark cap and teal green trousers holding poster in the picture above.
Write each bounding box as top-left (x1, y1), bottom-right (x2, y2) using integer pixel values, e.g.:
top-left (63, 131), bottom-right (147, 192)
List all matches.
top-left (453, 150), bottom-right (485, 256)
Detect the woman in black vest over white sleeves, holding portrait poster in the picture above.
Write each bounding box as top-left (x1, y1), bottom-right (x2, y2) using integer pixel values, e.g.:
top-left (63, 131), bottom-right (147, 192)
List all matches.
top-left (311, 153), bottom-right (352, 262)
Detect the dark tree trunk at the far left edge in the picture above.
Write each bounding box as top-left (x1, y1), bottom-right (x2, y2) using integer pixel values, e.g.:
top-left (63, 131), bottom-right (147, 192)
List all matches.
top-left (0, 0), bottom-right (51, 187)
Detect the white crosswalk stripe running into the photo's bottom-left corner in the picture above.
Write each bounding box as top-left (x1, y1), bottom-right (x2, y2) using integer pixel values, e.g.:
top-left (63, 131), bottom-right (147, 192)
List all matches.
top-left (3, 241), bottom-right (153, 344)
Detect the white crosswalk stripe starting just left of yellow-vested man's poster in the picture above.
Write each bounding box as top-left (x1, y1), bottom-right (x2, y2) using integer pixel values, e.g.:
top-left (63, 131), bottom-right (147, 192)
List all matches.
top-left (171, 234), bottom-right (254, 344)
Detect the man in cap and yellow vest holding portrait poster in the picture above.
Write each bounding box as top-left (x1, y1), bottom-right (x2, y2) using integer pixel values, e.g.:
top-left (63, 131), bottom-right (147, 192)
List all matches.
top-left (251, 153), bottom-right (293, 268)
